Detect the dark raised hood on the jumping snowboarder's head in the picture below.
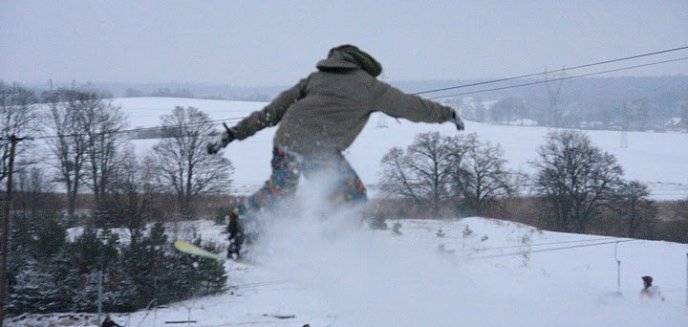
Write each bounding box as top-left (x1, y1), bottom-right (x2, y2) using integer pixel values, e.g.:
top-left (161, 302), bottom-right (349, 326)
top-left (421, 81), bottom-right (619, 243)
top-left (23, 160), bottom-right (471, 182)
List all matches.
top-left (316, 45), bottom-right (382, 77)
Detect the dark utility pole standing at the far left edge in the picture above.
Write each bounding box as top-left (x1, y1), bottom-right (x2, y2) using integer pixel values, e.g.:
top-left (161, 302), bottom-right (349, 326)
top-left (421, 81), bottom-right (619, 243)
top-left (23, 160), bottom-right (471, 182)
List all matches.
top-left (0, 134), bottom-right (23, 327)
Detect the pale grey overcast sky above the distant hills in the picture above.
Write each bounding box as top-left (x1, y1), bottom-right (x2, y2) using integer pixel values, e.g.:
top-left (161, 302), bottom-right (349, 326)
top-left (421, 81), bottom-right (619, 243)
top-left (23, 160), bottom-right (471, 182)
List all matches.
top-left (0, 0), bottom-right (688, 85)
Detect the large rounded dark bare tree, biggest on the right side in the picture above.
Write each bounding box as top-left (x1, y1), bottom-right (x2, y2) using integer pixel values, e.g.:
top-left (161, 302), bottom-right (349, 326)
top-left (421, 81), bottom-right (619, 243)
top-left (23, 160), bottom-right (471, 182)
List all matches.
top-left (532, 130), bottom-right (623, 233)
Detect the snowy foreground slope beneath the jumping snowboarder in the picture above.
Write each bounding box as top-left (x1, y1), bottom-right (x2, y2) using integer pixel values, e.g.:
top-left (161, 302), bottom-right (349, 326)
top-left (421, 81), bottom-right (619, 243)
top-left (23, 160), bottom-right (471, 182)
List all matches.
top-left (9, 215), bottom-right (688, 327)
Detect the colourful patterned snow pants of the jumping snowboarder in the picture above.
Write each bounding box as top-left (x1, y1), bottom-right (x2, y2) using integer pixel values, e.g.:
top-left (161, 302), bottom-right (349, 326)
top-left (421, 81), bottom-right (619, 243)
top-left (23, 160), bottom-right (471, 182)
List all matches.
top-left (238, 148), bottom-right (367, 215)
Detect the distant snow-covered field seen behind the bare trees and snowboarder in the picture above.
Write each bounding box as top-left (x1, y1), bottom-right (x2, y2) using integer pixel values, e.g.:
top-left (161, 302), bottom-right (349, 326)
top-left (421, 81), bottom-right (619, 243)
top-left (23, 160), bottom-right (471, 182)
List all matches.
top-left (115, 98), bottom-right (688, 199)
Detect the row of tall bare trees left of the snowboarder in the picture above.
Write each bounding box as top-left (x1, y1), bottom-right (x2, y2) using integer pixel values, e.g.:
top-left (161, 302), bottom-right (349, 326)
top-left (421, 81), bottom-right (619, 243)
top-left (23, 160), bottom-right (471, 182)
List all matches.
top-left (0, 82), bottom-right (233, 219)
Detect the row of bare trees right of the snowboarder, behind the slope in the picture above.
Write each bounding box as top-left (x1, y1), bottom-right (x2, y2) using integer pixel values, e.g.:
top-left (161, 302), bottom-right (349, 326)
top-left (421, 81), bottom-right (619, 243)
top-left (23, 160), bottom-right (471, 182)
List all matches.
top-left (379, 130), bottom-right (688, 241)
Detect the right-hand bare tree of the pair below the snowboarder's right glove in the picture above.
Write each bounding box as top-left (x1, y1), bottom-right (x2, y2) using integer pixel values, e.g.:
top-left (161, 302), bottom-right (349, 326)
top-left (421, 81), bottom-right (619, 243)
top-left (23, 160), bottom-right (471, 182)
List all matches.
top-left (453, 134), bottom-right (517, 215)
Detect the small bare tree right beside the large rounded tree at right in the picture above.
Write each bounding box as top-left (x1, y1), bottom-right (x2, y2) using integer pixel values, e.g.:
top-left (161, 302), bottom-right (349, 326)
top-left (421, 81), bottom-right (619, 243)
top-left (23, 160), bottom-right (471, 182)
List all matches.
top-left (612, 181), bottom-right (657, 237)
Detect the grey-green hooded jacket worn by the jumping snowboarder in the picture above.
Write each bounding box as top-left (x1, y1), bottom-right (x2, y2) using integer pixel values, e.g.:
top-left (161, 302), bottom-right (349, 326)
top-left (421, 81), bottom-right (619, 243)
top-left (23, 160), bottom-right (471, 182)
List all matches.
top-left (231, 48), bottom-right (453, 155)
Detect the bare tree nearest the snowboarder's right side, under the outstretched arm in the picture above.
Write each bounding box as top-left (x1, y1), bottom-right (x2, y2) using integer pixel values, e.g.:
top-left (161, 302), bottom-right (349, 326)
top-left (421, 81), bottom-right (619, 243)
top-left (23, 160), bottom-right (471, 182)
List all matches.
top-left (380, 132), bottom-right (456, 217)
